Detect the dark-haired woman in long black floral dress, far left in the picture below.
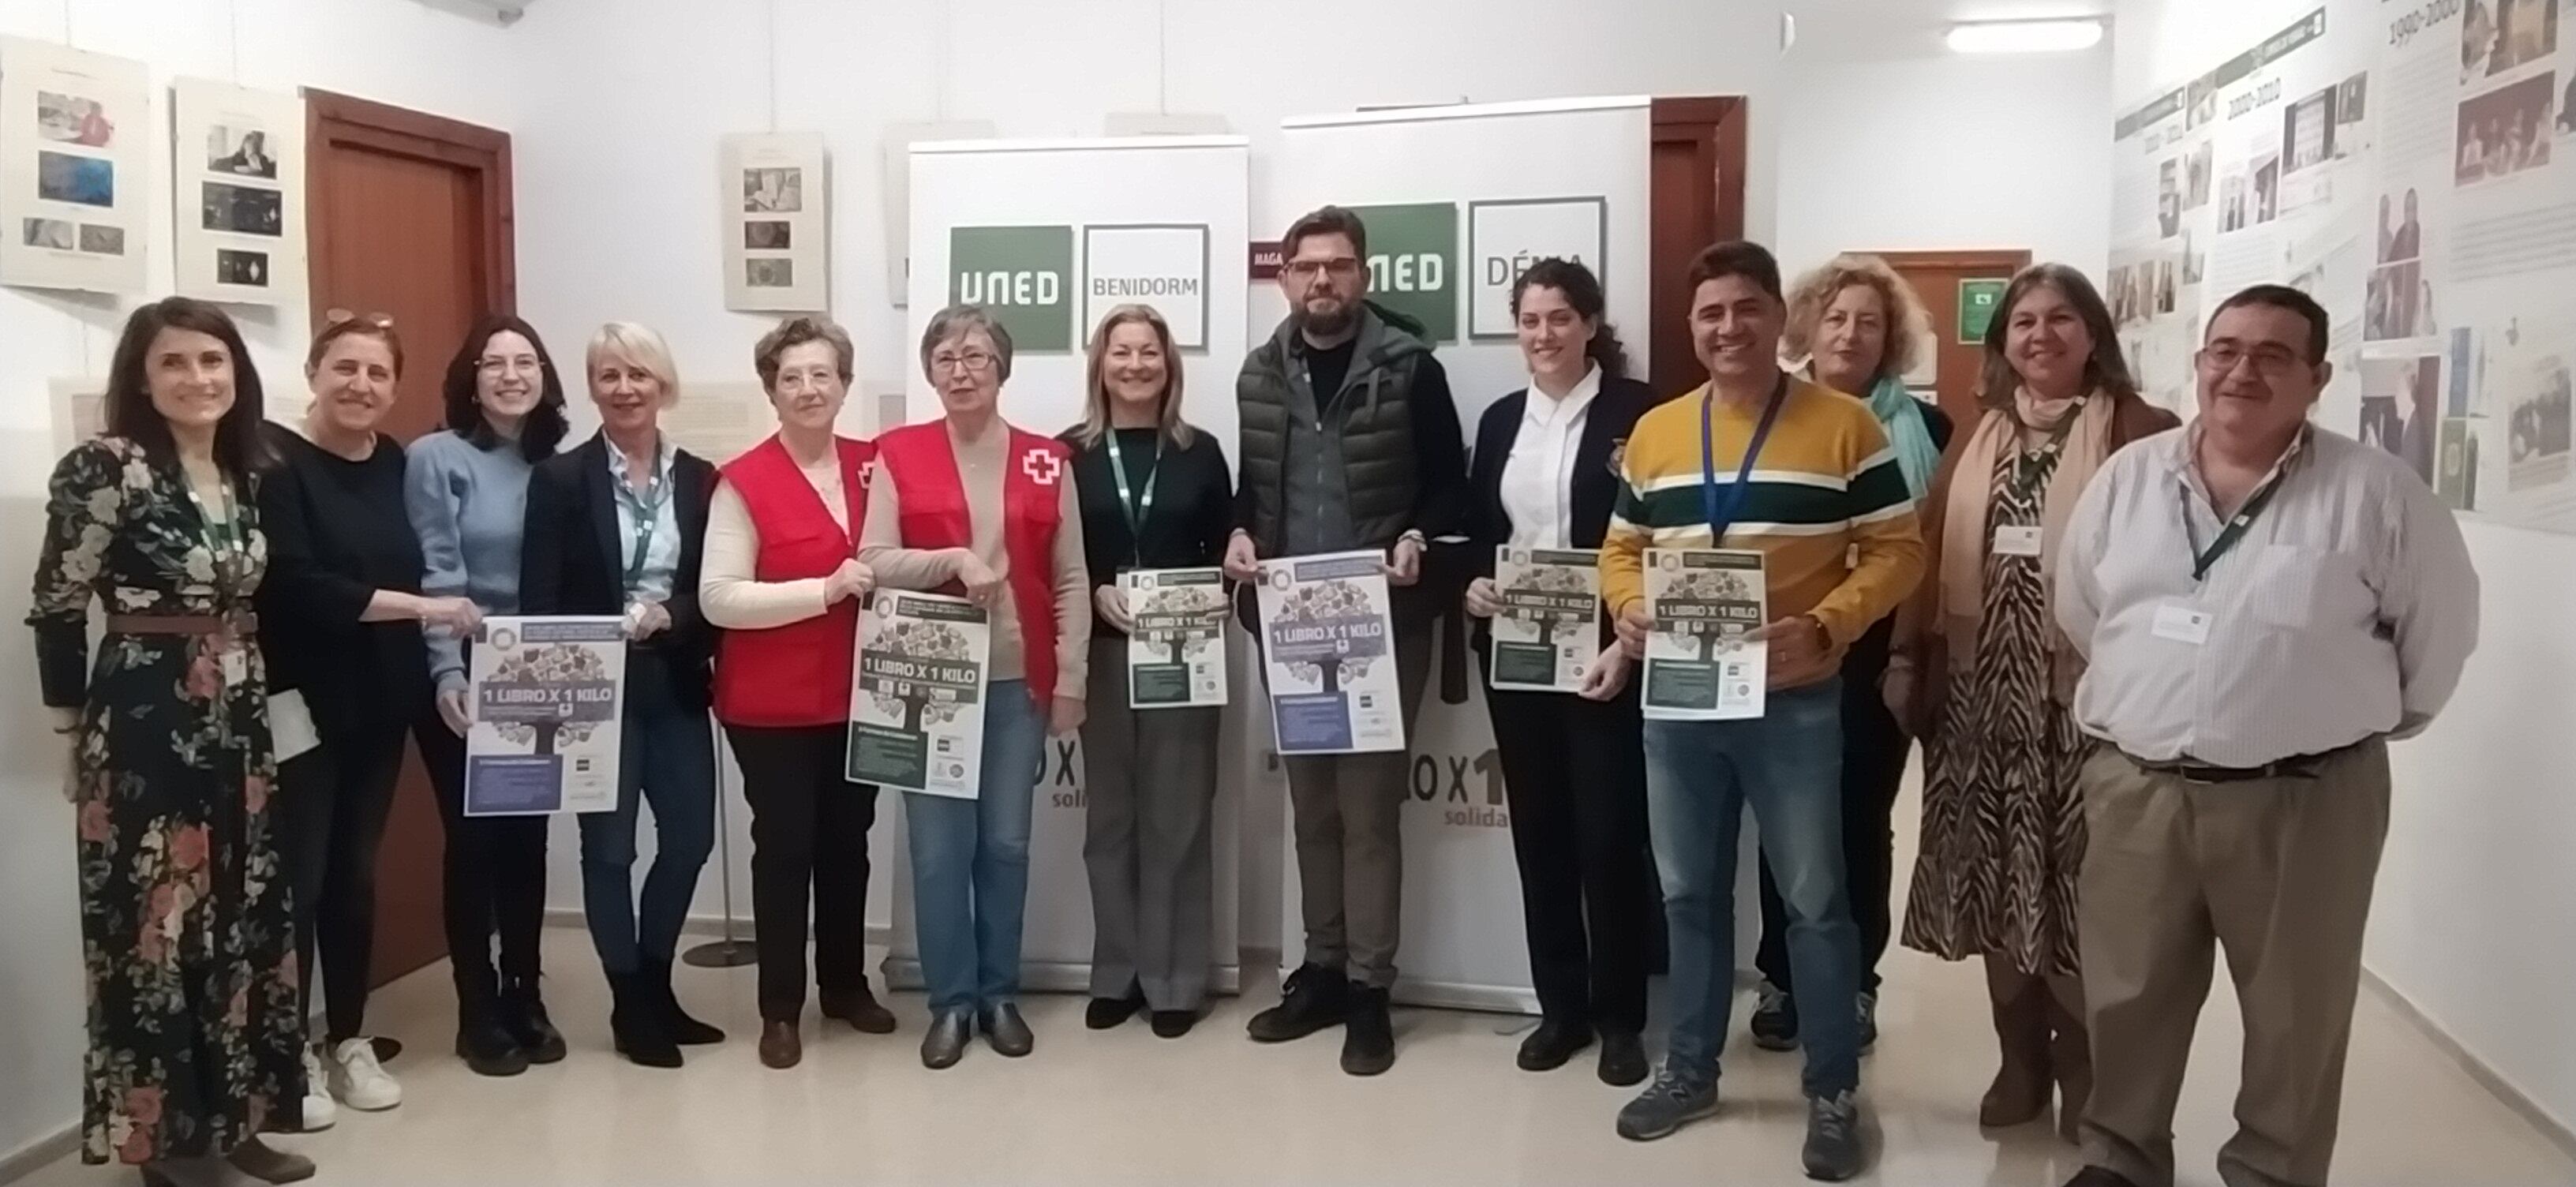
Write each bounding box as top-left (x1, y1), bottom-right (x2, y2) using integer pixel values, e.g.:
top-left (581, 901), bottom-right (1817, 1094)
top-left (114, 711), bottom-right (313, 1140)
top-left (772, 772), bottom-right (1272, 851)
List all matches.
top-left (28, 298), bottom-right (314, 1187)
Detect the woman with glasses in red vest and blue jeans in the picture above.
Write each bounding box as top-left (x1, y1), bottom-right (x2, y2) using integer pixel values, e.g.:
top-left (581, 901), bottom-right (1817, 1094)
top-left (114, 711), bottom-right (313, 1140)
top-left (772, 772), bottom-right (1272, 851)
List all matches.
top-left (865, 306), bottom-right (1092, 1069)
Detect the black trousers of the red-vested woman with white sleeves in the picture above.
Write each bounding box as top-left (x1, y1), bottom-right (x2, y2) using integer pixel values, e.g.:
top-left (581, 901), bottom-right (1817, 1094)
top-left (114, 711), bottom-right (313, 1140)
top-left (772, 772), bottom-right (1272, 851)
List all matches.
top-left (724, 726), bottom-right (876, 1022)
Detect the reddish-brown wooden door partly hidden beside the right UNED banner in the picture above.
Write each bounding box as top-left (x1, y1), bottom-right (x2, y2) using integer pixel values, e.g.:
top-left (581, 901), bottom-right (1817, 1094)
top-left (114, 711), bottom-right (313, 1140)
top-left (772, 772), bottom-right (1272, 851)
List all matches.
top-left (1631, 95), bottom-right (1744, 396)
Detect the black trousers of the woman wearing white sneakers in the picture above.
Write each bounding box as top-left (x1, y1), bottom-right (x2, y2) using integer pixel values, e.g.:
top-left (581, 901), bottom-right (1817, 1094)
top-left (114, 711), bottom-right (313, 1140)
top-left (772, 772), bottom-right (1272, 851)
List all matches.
top-left (279, 721), bottom-right (407, 1043)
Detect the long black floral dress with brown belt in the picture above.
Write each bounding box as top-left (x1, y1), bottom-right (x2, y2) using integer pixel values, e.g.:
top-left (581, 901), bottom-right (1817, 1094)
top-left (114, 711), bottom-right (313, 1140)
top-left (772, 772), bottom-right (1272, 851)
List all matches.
top-left (28, 438), bottom-right (304, 1164)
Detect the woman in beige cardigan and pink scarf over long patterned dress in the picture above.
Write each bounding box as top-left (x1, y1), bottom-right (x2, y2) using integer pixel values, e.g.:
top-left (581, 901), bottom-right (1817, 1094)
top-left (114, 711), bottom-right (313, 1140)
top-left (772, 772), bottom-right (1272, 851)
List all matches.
top-left (1883, 265), bottom-right (2177, 1138)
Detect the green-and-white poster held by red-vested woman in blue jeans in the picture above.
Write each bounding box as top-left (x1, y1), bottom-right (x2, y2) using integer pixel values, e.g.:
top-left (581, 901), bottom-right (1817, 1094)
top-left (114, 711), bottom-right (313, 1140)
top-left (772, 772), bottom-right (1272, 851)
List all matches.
top-left (848, 590), bottom-right (992, 801)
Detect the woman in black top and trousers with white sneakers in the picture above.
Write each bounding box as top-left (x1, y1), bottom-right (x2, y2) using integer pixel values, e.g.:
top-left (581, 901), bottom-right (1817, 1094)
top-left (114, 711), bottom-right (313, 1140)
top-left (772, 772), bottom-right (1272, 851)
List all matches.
top-left (260, 312), bottom-right (481, 1130)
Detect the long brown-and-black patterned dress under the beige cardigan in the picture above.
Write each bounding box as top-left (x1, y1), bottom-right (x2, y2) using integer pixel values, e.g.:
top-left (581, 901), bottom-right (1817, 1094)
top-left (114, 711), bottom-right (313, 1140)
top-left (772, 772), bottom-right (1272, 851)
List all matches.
top-left (1904, 440), bottom-right (2091, 975)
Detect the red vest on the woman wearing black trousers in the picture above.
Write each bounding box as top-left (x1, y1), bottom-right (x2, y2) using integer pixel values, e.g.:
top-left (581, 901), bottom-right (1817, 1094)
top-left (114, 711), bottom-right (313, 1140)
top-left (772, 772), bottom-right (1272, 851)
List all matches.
top-left (716, 435), bottom-right (876, 728)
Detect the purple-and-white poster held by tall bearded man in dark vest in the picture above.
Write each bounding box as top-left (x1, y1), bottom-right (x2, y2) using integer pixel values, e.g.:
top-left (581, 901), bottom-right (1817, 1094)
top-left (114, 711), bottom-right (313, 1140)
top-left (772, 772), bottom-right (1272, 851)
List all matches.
top-left (1260, 551), bottom-right (1404, 755)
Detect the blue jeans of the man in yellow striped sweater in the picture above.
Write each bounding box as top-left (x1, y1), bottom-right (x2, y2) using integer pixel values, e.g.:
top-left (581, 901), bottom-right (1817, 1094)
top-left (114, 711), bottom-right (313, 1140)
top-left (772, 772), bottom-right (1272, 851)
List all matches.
top-left (1646, 680), bottom-right (1860, 1097)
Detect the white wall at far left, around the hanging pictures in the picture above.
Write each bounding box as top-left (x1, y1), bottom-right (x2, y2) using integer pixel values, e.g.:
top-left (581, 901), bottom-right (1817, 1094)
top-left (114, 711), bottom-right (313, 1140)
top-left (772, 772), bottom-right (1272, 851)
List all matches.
top-left (0, 0), bottom-right (520, 1159)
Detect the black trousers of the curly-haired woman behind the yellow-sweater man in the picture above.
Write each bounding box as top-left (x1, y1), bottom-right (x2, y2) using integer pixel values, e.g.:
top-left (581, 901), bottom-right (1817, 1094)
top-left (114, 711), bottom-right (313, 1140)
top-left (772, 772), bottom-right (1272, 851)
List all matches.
top-left (1754, 618), bottom-right (1914, 994)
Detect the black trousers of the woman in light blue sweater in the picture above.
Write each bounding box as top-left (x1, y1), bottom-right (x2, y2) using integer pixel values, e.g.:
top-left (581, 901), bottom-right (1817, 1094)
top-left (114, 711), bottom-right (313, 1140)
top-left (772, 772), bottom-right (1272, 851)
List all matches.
top-left (412, 710), bottom-right (549, 1007)
